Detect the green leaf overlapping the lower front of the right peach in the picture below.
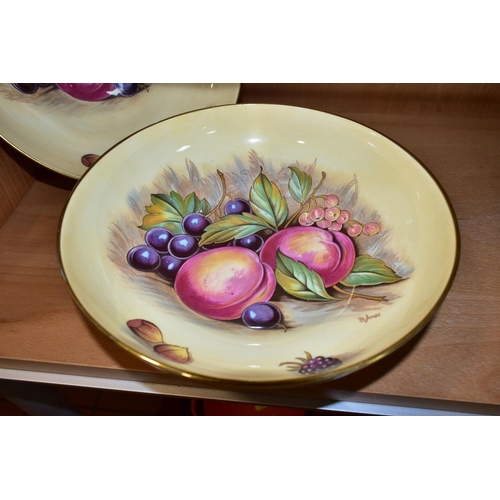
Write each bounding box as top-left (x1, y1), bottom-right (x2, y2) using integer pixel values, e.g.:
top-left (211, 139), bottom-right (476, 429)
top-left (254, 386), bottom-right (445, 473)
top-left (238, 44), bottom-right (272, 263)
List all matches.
top-left (274, 250), bottom-right (338, 302)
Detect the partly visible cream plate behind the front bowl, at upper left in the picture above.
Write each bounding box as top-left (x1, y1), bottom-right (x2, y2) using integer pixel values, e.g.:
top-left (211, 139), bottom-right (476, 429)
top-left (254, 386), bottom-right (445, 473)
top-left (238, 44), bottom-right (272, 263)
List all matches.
top-left (0, 83), bottom-right (240, 179)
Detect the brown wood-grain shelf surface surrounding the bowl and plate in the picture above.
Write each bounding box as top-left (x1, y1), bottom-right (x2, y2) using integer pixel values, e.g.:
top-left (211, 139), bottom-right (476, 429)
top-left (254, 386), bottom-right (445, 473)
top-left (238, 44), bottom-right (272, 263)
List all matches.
top-left (0, 84), bottom-right (500, 405)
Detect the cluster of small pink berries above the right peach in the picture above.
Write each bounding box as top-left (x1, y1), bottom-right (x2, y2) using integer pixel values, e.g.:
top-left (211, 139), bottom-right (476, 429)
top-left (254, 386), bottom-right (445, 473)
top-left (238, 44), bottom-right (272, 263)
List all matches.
top-left (299, 194), bottom-right (380, 237)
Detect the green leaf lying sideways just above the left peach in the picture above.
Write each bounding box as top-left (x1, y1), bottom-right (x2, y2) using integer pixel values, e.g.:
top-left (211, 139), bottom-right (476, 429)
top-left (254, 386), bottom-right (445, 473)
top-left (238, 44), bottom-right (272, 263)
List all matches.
top-left (199, 213), bottom-right (273, 247)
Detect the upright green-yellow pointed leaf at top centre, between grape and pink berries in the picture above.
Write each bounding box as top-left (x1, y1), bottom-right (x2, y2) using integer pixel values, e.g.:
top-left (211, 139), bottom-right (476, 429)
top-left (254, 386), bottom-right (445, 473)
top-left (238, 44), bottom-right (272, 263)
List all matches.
top-left (250, 173), bottom-right (288, 229)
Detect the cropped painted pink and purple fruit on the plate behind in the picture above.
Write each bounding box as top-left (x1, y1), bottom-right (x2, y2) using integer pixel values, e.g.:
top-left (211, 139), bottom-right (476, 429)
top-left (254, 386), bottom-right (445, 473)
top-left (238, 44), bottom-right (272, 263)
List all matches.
top-left (12, 83), bottom-right (143, 101)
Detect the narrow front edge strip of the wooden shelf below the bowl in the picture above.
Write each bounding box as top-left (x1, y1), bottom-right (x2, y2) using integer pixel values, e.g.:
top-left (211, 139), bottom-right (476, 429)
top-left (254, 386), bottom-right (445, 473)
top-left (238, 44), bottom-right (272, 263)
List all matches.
top-left (0, 360), bottom-right (500, 416)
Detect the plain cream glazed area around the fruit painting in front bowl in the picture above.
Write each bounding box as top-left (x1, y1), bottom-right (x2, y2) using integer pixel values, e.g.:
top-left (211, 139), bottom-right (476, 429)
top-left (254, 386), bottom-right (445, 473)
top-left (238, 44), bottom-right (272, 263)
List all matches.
top-left (60, 105), bottom-right (458, 383)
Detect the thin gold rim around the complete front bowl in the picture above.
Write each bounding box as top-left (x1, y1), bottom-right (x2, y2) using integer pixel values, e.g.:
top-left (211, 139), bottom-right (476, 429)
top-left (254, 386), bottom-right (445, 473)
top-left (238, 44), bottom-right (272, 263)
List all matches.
top-left (57, 103), bottom-right (460, 388)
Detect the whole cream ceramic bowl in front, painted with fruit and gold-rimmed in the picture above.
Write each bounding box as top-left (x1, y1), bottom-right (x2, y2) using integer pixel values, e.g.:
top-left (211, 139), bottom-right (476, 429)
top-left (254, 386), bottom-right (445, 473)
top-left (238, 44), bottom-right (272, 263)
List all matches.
top-left (59, 104), bottom-right (459, 385)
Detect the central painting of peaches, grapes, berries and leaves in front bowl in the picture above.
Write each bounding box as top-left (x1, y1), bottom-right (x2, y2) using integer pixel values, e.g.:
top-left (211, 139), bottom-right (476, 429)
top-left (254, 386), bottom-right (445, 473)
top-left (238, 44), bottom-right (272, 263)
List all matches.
top-left (124, 158), bottom-right (402, 332)
